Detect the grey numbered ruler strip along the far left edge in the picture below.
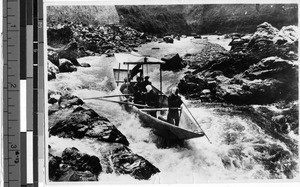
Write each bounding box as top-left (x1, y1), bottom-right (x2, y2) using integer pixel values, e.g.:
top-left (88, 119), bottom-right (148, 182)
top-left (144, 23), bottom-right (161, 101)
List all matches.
top-left (3, 0), bottom-right (21, 187)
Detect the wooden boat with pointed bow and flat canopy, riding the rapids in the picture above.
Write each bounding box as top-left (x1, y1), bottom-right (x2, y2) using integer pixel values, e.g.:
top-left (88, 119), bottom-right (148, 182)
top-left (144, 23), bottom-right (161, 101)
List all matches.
top-left (113, 51), bottom-right (205, 140)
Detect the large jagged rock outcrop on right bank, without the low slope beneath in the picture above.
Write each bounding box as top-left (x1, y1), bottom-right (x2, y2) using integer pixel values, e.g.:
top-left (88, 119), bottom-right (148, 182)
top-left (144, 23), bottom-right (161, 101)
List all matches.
top-left (178, 22), bottom-right (298, 104)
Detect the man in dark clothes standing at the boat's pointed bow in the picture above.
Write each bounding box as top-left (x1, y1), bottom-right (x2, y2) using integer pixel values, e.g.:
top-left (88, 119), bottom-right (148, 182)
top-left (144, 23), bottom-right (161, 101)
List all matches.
top-left (167, 87), bottom-right (183, 126)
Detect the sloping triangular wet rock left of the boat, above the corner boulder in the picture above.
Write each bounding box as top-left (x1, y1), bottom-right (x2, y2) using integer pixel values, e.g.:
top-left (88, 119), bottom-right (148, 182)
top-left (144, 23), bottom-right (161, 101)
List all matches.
top-left (49, 107), bottom-right (129, 145)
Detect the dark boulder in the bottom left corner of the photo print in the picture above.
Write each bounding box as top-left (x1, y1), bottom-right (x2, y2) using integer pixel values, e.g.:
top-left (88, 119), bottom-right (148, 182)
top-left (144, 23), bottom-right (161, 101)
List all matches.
top-left (49, 147), bottom-right (102, 181)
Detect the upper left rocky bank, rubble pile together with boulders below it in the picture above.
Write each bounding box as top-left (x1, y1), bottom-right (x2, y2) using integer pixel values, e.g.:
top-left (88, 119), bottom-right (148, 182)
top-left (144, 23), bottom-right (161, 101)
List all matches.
top-left (47, 22), bottom-right (157, 80)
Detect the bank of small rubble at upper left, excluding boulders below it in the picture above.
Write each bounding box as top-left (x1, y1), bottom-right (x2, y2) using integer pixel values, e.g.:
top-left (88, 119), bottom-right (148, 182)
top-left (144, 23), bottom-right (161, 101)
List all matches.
top-left (47, 23), bottom-right (151, 56)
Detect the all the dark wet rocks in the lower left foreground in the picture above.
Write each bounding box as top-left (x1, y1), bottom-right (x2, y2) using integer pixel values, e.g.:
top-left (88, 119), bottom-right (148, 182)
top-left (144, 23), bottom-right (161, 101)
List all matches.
top-left (48, 91), bottom-right (159, 181)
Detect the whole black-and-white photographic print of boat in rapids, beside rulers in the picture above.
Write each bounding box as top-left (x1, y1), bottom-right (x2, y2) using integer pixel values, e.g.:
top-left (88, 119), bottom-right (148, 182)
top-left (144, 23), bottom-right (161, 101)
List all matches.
top-left (44, 1), bottom-right (300, 184)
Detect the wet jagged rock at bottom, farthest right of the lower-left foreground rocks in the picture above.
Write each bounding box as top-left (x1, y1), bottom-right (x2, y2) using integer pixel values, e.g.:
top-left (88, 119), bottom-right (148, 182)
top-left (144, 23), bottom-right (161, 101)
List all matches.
top-left (111, 147), bottom-right (160, 180)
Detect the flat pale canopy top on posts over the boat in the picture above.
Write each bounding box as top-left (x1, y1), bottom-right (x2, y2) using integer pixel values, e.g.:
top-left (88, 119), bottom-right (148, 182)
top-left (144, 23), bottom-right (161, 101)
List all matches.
top-left (115, 52), bottom-right (165, 64)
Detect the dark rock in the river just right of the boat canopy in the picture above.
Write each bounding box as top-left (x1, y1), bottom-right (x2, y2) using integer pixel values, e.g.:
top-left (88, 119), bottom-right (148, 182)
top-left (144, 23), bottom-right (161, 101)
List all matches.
top-left (161, 54), bottom-right (186, 71)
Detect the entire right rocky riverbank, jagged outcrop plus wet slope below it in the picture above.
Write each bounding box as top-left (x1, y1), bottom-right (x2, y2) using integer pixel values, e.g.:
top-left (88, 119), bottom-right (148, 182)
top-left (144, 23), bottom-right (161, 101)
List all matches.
top-left (178, 22), bottom-right (299, 155)
